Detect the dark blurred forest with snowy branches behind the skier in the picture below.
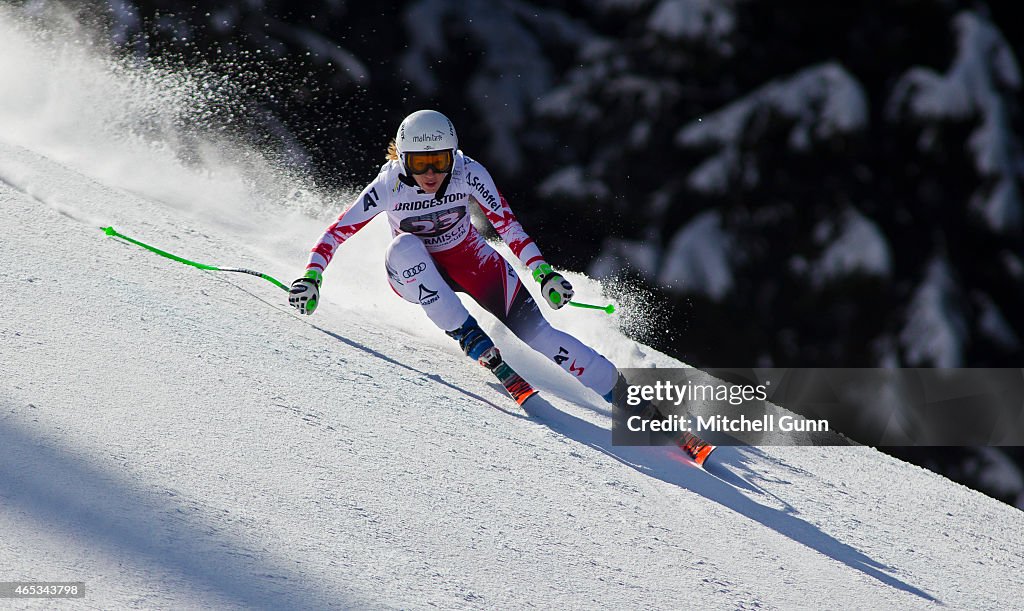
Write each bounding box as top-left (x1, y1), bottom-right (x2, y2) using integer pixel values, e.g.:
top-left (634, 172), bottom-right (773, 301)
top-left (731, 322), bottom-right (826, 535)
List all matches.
top-left (14, 0), bottom-right (1024, 508)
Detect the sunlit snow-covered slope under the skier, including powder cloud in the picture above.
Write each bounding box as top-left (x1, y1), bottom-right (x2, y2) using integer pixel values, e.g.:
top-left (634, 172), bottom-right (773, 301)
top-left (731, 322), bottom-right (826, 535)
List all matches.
top-left (0, 5), bottom-right (1024, 609)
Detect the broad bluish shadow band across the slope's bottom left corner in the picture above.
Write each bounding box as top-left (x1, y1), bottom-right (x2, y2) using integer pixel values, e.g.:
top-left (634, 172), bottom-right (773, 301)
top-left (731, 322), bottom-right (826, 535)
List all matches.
top-left (0, 402), bottom-right (346, 609)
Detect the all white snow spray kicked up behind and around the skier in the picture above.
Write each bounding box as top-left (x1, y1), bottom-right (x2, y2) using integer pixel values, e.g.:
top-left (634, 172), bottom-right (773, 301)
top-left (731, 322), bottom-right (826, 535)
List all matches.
top-left (0, 7), bottom-right (671, 376)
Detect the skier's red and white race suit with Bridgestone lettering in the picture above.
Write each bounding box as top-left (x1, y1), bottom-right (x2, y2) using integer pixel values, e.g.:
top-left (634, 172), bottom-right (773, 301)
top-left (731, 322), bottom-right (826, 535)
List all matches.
top-left (306, 150), bottom-right (617, 395)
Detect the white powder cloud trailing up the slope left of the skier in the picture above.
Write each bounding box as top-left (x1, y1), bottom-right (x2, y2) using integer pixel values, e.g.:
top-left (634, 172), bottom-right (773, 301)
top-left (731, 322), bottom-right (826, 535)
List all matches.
top-left (0, 3), bottom-right (362, 317)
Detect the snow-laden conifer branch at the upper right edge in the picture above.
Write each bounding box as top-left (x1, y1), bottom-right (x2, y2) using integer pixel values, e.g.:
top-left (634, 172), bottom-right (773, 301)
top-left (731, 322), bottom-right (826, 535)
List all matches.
top-left (887, 12), bottom-right (1024, 233)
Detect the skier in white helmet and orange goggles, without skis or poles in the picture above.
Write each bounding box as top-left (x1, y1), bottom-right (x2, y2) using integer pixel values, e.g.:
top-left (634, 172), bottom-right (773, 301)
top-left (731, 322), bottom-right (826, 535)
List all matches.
top-left (289, 111), bottom-right (618, 402)
